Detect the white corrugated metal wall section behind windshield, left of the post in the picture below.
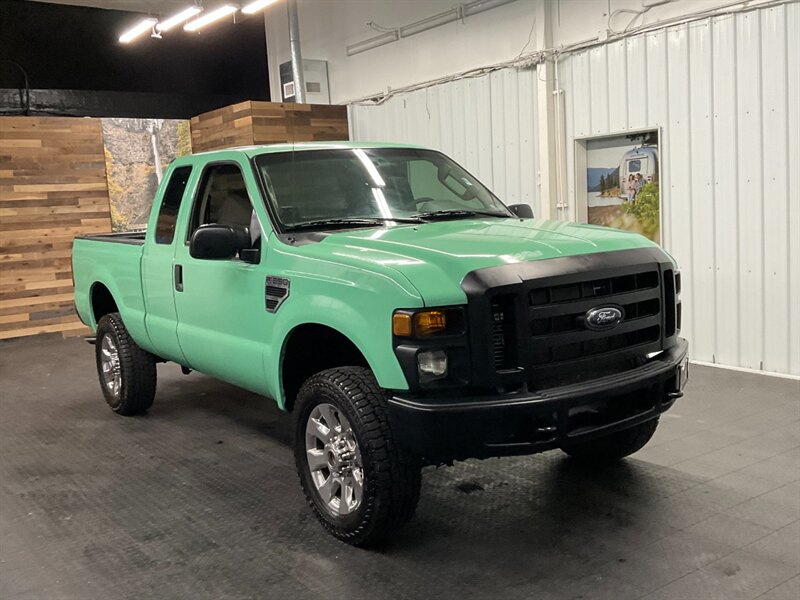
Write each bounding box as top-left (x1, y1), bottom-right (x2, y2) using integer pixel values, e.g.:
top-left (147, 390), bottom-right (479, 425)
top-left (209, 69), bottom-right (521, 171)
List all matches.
top-left (350, 69), bottom-right (539, 212)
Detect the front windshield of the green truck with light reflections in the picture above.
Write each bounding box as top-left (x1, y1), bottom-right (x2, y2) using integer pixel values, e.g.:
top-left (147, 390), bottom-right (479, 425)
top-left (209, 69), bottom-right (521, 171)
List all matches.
top-left (256, 148), bottom-right (513, 229)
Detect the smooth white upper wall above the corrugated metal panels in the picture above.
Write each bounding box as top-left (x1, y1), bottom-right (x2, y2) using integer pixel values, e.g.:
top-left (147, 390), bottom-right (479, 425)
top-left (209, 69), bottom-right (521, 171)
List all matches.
top-left (264, 0), bottom-right (764, 104)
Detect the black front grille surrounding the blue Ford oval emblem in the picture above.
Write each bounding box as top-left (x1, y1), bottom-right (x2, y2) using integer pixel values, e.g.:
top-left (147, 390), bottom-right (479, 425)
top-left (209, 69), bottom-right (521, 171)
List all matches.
top-left (462, 248), bottom-right (680, 390)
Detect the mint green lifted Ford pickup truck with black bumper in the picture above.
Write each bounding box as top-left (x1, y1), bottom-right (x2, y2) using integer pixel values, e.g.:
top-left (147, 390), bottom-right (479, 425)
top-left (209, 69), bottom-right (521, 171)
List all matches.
top-left (73, 143), bottom-right (688, 545)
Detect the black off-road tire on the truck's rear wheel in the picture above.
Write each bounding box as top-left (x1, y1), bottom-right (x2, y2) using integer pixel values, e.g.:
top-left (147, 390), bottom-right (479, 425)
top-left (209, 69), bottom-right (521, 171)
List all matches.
top-left (95, 313), bottom-right (156, 416)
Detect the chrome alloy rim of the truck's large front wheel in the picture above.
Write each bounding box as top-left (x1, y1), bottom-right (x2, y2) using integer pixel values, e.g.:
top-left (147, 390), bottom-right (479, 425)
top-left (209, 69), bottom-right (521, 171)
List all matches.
top-left (306, 403), bottom-right (364, 517)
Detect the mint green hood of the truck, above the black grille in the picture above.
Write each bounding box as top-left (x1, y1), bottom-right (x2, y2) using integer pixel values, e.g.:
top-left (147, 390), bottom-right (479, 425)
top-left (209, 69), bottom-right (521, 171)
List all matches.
top-left (306, 218), bottom-right (655, 306)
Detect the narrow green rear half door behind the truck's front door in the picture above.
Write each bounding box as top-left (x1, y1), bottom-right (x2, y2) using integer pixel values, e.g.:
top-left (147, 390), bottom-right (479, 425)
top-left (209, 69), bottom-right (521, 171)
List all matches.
top-left (142, 165), bottom-right (192, 364)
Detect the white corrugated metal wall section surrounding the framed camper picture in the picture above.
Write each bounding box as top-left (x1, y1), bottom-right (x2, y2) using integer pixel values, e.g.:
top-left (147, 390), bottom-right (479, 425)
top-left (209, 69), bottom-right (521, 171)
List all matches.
top-left (558, 3), bottom-right (800, 375)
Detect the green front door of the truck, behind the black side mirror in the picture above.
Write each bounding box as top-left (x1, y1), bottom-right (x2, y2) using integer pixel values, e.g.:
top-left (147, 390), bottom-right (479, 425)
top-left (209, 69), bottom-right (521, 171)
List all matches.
top-left (174, 161), bottom-right (269, 393)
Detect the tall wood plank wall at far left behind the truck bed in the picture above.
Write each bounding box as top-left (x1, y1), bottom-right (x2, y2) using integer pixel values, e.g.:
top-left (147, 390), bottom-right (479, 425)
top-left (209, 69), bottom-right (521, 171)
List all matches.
top-left (0, 117), bottom-right (111, 339)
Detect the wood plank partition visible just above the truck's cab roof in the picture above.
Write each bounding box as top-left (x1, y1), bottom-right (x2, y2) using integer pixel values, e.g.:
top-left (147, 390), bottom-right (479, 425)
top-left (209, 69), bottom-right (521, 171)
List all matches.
top-left (191, 100), bottom-right (349, 152)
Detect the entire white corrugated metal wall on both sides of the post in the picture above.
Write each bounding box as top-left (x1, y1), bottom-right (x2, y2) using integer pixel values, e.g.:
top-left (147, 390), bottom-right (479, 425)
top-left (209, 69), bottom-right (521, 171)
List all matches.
top-left (350, 3), bottom-right (800, 375)
